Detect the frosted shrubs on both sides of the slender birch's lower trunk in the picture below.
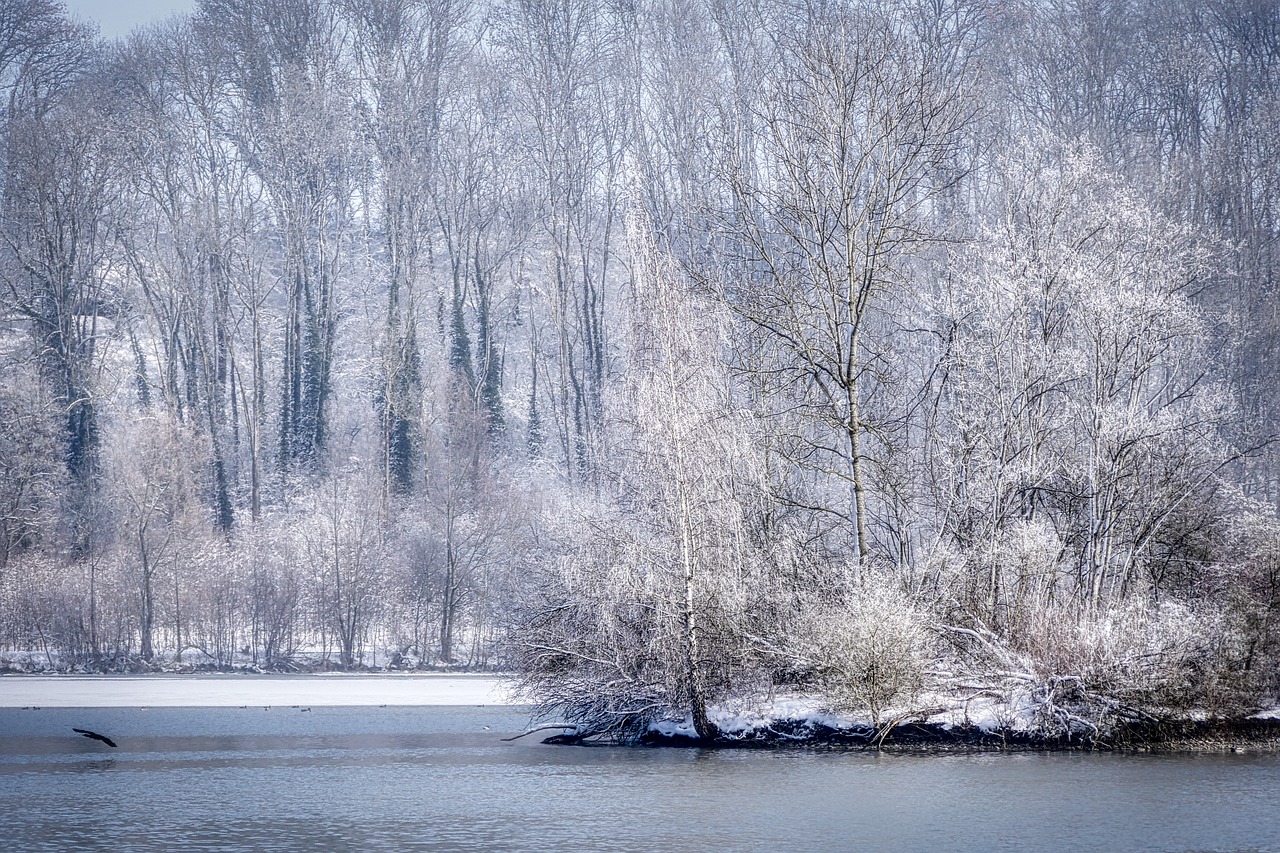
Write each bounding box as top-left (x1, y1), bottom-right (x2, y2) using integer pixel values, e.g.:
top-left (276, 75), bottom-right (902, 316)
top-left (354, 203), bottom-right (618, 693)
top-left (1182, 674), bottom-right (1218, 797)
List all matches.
top-left (503, 489), bottom-right (780, 742)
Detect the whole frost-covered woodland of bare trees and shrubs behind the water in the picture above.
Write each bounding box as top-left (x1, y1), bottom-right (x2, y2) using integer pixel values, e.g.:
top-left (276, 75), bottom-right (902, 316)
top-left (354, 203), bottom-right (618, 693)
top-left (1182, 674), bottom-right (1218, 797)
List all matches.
top-left (0, 0), bottom-right (1280, 739)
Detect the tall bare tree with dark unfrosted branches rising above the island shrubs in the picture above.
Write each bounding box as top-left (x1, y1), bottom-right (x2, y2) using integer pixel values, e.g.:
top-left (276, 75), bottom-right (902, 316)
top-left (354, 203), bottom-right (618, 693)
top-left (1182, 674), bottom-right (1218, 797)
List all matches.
top-left (712, 6), bottom-right (968, 569)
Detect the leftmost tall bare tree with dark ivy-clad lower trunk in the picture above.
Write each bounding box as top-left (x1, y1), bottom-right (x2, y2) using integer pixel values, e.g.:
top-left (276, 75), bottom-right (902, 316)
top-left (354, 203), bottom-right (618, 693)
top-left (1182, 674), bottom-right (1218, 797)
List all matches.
top-left (0, 60), bottom-right (119, 552)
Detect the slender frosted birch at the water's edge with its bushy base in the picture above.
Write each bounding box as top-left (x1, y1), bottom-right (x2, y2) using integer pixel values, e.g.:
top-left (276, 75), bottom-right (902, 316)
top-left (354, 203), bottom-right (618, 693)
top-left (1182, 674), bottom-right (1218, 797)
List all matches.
top-left (513, 222), bottom-right (773, 739)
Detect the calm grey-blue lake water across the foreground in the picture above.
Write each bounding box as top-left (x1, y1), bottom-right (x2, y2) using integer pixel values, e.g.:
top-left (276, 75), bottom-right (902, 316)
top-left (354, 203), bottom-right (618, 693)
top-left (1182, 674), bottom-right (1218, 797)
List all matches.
top-left (0, 707), bottom-right (1280, 853)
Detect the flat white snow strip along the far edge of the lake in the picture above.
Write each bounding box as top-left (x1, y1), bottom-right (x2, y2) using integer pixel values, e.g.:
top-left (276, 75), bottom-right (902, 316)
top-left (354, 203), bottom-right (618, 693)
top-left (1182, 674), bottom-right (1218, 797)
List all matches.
top-left (0, 674), bottom-right (513, 708)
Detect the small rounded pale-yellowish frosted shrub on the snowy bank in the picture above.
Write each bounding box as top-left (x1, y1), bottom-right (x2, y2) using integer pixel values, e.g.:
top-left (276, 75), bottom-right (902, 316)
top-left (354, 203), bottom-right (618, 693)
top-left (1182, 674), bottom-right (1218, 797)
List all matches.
top-left (800, 580), bottom-right (929, 725)
